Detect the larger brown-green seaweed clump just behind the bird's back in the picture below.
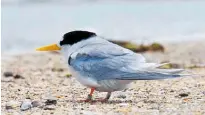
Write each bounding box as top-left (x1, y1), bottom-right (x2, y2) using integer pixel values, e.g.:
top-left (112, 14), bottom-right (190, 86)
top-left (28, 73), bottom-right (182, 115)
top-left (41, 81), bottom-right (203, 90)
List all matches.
top-left (109, 40), bottom-right (165, 52)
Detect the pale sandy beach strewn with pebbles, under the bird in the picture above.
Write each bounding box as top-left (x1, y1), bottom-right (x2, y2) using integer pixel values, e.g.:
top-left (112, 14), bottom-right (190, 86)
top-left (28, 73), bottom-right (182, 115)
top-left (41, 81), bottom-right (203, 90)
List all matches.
top-left (1, 41), bottom-right (205, 115)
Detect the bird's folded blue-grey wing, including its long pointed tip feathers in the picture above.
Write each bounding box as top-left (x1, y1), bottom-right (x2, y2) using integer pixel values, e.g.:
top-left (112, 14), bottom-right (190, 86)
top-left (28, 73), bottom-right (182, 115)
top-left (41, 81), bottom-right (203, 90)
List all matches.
top-left (70, 44), bottom-right (183, 81)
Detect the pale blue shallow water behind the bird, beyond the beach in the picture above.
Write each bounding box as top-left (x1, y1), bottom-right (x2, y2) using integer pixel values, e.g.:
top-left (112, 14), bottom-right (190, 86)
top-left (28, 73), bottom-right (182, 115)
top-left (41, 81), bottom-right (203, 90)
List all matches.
top-left (1, 1), bottom-right (205, 53)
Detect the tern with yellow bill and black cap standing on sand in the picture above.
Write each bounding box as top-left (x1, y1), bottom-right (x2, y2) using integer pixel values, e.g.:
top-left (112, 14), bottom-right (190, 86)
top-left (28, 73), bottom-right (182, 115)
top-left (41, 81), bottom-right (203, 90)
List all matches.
top-left (36, 30), bottom-right (187, 102)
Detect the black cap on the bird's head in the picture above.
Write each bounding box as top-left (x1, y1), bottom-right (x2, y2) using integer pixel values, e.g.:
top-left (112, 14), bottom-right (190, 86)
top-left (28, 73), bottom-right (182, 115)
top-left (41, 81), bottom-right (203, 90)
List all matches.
top-left (60, 30), bottom-right (96, 46)
